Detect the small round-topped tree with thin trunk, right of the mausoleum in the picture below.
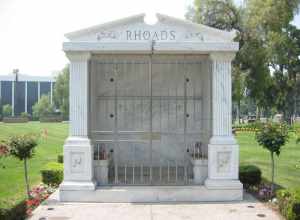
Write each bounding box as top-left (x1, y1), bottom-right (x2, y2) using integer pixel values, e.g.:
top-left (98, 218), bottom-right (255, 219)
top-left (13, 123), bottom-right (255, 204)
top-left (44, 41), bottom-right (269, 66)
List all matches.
top-left (256, 123), bottom-right (289, 194)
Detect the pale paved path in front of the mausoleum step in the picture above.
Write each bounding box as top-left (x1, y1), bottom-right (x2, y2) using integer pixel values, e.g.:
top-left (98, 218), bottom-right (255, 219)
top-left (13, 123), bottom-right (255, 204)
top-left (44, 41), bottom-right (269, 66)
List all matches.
top-left (30, 192), bottom-right (281, 220)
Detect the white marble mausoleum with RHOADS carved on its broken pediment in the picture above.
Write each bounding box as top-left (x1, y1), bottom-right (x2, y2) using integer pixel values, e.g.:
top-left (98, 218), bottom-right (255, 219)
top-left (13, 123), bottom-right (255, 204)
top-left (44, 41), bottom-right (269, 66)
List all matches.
top-left (60, 14), bottom-right (243, 202)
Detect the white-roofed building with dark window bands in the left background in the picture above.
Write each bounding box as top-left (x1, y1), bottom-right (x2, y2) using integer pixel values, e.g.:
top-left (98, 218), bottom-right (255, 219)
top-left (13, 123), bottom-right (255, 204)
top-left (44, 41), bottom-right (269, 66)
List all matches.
top-left (0, 74), bottom-right (55, 116)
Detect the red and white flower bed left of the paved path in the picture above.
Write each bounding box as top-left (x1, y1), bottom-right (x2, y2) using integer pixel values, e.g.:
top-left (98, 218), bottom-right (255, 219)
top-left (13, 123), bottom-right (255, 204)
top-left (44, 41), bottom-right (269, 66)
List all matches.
top-left (26, 184), bottom-right (55, 216)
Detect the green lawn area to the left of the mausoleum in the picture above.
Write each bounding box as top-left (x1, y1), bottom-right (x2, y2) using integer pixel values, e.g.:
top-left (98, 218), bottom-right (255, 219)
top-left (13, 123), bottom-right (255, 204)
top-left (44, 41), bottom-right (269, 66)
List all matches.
top-left (0, 122), bottom-right (68, 207)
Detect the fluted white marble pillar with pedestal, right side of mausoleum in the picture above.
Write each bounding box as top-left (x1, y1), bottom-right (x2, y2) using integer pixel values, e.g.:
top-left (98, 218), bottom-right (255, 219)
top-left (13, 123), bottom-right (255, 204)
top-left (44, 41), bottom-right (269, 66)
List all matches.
top-left (205, 52), bottom-right (242, 195)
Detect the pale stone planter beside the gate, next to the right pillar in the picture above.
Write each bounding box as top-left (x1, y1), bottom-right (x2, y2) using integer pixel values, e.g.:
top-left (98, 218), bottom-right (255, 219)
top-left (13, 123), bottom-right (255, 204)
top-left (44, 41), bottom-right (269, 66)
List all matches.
top-left (191, 159), bottom-right (208, 185)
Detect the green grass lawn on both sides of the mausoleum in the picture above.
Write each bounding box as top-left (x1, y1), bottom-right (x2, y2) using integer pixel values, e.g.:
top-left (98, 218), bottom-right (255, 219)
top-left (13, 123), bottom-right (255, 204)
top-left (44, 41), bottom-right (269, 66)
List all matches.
top-left (0, 122), bottom-right (300, 210)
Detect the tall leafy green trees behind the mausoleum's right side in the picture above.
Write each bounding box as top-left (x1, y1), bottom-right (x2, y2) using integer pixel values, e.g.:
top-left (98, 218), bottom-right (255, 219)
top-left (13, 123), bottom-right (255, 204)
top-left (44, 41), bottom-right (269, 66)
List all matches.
top-left (186, 0), bottom-right (300, 122)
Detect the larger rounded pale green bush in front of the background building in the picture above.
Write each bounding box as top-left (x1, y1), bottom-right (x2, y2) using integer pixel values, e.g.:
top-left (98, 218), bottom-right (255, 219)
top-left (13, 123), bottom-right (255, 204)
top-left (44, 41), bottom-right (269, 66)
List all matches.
top-left (32, 95), bottom-right (55, 118)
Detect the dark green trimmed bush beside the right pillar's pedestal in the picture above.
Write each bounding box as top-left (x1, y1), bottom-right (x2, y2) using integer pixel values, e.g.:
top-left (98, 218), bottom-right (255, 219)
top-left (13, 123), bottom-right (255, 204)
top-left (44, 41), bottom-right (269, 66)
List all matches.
top-left (239, 165), bottom-right (261, 187)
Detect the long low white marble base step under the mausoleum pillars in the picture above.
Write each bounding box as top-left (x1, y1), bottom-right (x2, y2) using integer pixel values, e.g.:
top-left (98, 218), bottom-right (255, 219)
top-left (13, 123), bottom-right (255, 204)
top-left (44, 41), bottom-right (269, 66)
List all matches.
top-left (59, 185), bottom-right (243, 203)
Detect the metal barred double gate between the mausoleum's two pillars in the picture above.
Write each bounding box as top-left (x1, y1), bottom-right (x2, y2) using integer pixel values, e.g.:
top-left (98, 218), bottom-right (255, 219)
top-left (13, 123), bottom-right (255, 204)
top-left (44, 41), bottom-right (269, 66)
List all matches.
top-left (91, 55), bottom-right (202, 185)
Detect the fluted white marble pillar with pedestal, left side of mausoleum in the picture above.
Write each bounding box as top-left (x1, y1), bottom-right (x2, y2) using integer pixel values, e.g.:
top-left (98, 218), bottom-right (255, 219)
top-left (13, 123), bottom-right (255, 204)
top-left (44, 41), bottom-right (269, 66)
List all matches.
top-left (60, 52), bottom-right (95, 201)
